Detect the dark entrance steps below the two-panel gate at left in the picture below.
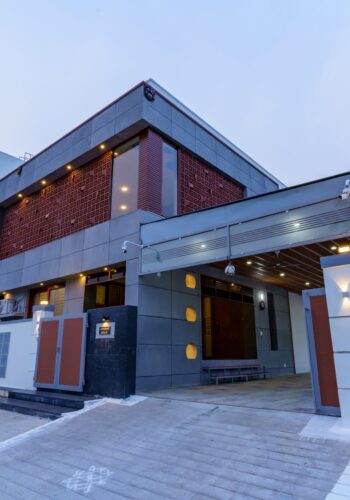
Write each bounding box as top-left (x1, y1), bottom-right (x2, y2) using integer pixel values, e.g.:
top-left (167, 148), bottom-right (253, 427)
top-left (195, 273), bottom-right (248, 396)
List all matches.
top-left (0, 389), bottom-right (99, 420)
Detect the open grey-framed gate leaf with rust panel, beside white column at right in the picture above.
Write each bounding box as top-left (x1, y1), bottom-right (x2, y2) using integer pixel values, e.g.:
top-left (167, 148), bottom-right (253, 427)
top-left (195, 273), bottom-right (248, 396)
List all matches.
top-left (303, 288), bottom-right (340, 416)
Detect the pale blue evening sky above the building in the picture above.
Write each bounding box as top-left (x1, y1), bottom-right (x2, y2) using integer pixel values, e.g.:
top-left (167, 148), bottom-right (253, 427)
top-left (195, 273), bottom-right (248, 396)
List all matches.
top-left (0, 0), bottom-right (350, 185)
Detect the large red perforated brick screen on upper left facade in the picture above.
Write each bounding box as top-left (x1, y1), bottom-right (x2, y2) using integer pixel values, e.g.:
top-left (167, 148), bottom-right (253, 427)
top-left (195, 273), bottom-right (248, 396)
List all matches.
top-left (0, 152), bottom-right (112, 259)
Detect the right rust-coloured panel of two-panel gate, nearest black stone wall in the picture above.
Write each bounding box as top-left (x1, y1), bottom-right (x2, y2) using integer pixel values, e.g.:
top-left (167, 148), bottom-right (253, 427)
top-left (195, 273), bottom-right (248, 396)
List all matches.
top-left (59, 318), bottom-right (84, 387)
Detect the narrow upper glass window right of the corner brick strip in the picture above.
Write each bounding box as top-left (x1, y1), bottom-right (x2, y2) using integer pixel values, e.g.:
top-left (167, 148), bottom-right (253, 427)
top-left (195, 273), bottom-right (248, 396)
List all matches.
top-left (162, 142), bottom-right (177, 217)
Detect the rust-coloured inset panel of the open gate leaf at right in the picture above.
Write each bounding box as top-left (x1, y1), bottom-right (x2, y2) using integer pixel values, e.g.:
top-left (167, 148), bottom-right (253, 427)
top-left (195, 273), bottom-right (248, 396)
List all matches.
top-left (310, 295), bottom-right (339, 407)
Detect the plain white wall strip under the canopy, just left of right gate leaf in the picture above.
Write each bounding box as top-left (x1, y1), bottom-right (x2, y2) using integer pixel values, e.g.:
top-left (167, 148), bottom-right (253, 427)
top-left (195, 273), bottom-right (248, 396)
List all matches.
top-left (288, 292), bottom-right (310, 373)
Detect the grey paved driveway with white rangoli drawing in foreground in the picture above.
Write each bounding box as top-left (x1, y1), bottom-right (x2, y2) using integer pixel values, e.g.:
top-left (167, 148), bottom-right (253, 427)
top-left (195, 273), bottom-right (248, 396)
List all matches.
top-left (0, 398), bottom-right (350, 500)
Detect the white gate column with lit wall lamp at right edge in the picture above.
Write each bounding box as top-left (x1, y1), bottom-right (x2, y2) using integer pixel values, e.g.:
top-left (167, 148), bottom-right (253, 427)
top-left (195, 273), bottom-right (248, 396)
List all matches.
top-left (321, 254), bottom-right (350, 425)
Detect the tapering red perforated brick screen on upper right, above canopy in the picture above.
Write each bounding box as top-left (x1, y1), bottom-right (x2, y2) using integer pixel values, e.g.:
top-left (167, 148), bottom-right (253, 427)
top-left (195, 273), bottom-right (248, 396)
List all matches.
top-left (178, 146), bottom-right (244, 214)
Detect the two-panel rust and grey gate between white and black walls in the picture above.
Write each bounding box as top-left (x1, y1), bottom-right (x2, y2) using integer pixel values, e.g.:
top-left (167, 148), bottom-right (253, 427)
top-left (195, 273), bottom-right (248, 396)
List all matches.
top-left (34, 314), bottom-right (87, 392)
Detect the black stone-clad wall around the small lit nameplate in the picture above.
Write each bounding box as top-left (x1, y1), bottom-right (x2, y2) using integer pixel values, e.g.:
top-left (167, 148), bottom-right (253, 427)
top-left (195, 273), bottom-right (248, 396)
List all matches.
top-left (84, 306), bottom-right (137, 398)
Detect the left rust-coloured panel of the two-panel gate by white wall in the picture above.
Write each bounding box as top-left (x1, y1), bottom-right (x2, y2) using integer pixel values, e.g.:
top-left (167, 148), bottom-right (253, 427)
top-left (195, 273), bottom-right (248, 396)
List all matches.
top-left (36, 320), bottom-right (59, 384)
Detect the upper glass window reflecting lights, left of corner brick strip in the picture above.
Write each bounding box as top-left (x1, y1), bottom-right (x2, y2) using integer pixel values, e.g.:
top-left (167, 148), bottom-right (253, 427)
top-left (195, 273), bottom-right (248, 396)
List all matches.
top-left (111, 141), bottom-right (139, 218)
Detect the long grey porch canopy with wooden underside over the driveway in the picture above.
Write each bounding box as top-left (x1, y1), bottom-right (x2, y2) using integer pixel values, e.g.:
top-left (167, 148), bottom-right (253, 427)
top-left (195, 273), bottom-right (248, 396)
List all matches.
top-left (140, 172), bottom-right (350, 291)
